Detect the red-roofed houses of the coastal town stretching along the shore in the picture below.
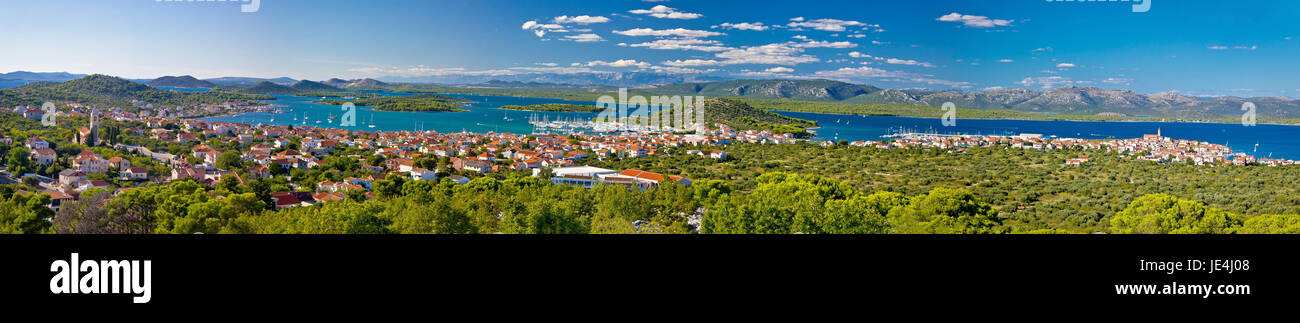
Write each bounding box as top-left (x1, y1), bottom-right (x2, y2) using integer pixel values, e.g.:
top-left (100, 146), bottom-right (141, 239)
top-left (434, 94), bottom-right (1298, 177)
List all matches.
top-left (0, 102), bottom-right (1296, 210)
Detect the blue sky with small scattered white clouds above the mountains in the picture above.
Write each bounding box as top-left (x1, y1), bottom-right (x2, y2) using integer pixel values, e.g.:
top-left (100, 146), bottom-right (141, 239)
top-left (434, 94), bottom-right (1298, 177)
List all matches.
top-left (0, 0), bottom-right (1300, 96)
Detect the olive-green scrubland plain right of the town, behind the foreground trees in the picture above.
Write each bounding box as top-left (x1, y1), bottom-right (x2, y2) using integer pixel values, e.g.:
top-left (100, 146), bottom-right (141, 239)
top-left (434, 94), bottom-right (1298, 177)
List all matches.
top-left (593, 143), bottom-right (1300, 233)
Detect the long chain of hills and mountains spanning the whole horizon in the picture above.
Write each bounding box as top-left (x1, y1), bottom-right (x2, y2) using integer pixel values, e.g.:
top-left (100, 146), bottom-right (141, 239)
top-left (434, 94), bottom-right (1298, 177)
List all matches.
top-left (10, 72), bottom-right (1300, 120)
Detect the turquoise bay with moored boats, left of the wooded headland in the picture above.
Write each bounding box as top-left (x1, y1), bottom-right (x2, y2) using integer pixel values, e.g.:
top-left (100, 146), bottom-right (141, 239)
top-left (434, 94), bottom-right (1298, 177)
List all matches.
top-left (204, 92), bottom-right (597, 134)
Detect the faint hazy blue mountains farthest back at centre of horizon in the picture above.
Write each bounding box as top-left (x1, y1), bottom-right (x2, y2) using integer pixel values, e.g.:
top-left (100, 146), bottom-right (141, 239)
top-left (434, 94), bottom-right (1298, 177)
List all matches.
top-left (378, 72), bottom-right (731, 87)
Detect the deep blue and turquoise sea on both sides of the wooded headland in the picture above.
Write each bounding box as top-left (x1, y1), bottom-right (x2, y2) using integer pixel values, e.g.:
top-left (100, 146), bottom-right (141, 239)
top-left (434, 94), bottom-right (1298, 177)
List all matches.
top-left (183, 92), bottom-right (1300, 159)
